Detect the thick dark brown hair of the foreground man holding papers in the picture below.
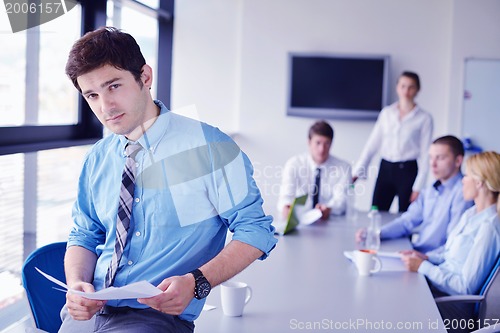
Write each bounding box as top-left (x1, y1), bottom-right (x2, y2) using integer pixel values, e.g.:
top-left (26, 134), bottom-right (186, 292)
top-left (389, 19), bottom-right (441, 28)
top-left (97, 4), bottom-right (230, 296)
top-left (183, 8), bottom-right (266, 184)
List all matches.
top-left (66, 27), bottom-right (146, 92)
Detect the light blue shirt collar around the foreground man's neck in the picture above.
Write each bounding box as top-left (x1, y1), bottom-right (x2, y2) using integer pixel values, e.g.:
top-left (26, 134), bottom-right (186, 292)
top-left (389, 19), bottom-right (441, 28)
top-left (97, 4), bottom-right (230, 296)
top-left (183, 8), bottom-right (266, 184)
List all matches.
top-left (119, 100), bottom-right (170, 153)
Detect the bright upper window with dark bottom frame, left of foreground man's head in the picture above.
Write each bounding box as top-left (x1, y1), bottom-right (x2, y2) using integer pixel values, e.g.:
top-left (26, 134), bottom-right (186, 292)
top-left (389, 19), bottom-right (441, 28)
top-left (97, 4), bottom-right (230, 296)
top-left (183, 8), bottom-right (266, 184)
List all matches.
top-left (0, 1), bottom-right (102, 155)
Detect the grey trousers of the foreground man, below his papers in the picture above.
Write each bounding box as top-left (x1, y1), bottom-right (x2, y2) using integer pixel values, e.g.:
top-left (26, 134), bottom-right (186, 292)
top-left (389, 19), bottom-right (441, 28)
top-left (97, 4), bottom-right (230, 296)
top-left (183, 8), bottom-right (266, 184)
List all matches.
top-left (59, 306), bottom-right (194, 333)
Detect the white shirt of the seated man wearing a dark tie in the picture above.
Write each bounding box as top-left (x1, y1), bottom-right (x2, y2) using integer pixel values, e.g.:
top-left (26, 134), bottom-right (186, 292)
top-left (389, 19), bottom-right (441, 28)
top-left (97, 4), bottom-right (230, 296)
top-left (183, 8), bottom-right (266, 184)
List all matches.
top-left (278, 153), bottom-right (351, 215)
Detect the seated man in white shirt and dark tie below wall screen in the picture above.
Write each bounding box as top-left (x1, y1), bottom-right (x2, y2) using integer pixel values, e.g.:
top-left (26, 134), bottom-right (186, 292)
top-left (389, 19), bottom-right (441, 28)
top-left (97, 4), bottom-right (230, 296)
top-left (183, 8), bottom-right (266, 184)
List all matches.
top-left (278, 120), bottom-right (351, 220)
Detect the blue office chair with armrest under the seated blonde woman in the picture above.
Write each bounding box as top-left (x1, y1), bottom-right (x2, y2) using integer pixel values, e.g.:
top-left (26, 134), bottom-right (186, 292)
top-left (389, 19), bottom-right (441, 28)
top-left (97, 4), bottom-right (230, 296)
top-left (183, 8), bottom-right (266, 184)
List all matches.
top-left (435, 255), bottom-right (500, 332)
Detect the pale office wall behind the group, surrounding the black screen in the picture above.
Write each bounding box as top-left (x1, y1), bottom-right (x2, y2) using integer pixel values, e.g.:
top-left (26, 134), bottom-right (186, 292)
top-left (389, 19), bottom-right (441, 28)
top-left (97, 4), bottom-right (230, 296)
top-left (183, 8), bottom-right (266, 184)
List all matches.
top-left (172, 0), bottom-right (500, 212)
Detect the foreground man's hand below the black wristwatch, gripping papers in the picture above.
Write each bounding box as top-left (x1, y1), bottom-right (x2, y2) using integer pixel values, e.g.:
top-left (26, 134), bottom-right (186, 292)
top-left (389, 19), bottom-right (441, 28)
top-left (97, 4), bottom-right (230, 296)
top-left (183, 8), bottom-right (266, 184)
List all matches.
top-left (137, 273), bottom-right (195, 315)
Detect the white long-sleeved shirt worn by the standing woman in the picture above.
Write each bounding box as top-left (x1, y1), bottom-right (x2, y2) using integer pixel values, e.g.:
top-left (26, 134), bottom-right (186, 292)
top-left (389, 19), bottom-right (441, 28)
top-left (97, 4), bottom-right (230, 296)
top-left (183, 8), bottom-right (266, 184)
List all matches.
top-left (353, 103), bottom-right (433, 192)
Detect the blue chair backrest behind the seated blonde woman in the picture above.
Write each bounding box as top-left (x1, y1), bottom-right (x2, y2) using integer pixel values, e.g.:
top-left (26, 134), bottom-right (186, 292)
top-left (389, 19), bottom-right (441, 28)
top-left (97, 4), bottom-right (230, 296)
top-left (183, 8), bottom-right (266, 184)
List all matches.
top-left (479, 256), bottom-right (500, 319)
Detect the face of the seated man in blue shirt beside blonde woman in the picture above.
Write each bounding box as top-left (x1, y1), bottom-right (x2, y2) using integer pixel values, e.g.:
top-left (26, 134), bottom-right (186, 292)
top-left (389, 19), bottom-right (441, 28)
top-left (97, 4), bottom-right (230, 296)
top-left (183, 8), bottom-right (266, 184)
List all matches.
top-left (429, 143), bottom-right (463, 182)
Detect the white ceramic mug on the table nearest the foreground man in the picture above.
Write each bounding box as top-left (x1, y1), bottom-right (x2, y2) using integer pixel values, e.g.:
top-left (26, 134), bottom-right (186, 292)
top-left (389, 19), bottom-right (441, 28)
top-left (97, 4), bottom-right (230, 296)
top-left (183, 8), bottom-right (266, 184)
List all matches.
top-left (220, 281), bottom-right (252, 317)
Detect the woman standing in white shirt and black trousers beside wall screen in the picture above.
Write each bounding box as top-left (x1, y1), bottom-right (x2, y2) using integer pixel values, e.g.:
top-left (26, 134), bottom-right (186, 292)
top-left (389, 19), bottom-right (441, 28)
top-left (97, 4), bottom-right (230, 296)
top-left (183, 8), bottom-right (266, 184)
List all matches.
top-left (352, 72), bottom-right (433, 212)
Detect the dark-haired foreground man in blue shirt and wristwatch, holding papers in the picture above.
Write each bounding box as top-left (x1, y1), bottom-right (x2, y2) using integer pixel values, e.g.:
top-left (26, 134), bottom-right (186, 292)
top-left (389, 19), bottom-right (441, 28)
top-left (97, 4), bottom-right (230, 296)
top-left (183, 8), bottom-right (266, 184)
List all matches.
top-left (61, 28), bottom-right (277, 333)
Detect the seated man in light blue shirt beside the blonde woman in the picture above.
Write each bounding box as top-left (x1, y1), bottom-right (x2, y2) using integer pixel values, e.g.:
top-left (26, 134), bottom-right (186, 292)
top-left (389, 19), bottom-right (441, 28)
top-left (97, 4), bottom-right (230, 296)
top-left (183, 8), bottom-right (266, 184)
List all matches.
top-left (356, 135), bottom-right (473, 253)
